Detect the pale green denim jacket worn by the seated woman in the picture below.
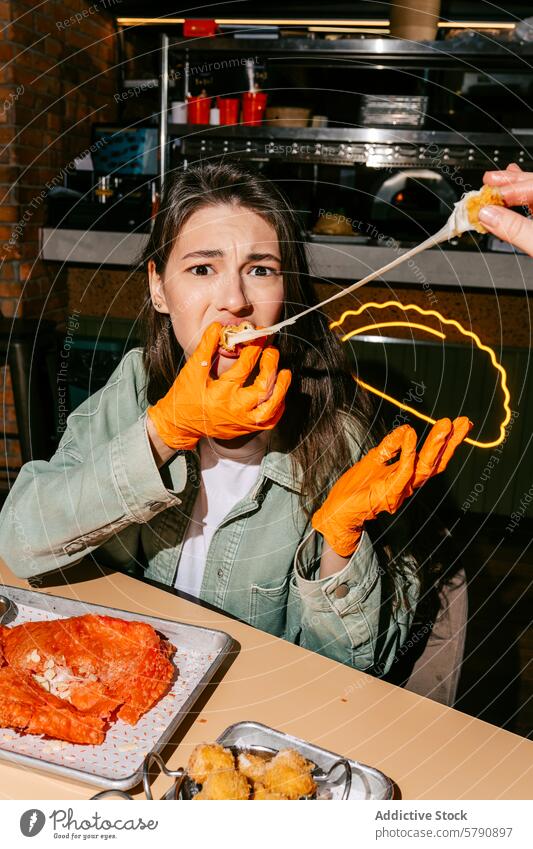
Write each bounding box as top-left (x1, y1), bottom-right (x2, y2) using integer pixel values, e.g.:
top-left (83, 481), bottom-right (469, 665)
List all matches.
top-left (0, 348), bottom-right (419, 675)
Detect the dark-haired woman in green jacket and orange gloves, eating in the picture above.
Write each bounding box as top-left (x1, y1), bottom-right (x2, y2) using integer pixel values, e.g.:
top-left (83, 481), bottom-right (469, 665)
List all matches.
top-left (0, 159), bottom-right (471, 675)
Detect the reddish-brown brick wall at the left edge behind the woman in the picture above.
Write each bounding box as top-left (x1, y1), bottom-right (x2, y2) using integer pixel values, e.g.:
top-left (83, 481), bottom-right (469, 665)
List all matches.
top-left (0, 0), bottom-right (116, 489)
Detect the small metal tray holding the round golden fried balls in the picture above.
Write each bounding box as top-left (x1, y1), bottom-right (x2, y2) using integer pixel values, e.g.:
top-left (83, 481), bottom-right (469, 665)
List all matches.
top-left (217, 722), bottom-right (394, 801)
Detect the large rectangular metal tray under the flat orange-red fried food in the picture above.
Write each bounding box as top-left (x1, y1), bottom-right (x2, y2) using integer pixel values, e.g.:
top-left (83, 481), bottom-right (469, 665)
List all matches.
top-left (0, 585), bottom-right (233, 790)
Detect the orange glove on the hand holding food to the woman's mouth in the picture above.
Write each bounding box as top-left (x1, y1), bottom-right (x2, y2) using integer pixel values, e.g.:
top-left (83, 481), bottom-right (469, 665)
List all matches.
top-left (148, 322), bottom-right (291, 450)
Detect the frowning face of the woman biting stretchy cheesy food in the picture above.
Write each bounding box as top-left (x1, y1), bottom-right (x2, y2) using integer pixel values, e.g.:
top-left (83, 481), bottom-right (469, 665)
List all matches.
top-left (148, 204), bottom-right (284, 376)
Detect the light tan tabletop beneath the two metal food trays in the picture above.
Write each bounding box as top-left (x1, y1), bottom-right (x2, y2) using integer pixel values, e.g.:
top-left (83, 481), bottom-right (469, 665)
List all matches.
top-left (0, 561), bottom-right (533, 800)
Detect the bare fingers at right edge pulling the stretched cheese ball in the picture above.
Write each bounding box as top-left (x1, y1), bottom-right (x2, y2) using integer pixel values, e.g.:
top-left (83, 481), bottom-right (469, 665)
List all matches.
top-left (479, 163), bottom-right (533, 256)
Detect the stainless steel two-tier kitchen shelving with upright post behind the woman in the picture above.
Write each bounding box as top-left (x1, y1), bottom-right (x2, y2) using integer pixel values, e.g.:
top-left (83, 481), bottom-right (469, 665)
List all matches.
top-left (155, 31), bottom-right (533, 184)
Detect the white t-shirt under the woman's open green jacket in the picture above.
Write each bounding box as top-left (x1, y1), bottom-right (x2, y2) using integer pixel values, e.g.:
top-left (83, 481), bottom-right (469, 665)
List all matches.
top-left (174, 431), bottom-right (270, 597)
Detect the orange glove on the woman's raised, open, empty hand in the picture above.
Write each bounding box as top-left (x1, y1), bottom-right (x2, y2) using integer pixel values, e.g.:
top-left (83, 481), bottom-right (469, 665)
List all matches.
top-left (311, 416), bottom-right (472, 557)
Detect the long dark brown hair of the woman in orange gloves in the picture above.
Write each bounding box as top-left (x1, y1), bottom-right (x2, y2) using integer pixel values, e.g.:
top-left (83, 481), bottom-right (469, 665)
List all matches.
top-left (142, 162), bottom-right (372, 513)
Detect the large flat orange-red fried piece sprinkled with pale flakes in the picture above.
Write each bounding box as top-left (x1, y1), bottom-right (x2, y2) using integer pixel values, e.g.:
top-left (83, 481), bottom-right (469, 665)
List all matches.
top-left (0, 614), bottom-right (176, 743)
